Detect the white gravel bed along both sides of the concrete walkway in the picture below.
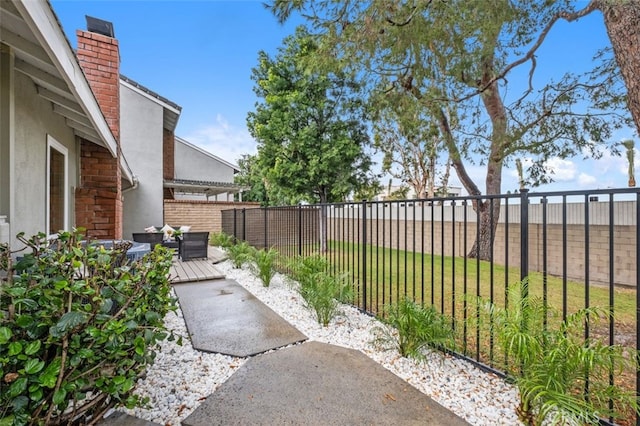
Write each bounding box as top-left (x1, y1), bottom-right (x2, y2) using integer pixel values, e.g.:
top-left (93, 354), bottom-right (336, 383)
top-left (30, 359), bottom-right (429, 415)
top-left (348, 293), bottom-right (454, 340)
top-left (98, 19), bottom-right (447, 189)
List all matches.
top-left (117, 261), bottom-right (521, 425)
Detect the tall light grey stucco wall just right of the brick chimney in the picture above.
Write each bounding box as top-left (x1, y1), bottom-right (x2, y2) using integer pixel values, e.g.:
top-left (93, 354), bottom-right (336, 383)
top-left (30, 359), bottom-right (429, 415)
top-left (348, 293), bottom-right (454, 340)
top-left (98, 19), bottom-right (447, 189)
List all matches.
top-left (120, 83), bottom-right (163, 239)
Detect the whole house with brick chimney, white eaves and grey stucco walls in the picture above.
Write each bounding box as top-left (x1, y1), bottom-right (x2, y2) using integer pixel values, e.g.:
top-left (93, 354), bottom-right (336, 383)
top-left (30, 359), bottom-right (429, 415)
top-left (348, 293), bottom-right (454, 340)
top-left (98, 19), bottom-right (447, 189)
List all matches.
top-left (0, 0), bottom-right (248, 249)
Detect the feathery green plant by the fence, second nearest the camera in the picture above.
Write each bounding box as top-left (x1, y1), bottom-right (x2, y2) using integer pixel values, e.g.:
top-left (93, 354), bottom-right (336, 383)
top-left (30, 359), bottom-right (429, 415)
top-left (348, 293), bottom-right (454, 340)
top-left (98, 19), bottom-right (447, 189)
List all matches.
top-left (374, 297), bottom-right (454, 359)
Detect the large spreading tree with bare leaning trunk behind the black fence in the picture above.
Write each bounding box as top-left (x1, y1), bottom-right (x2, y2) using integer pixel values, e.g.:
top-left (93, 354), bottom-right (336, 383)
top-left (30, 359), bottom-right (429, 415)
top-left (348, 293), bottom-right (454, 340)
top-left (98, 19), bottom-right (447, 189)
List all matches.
top-left (270, 0), bottom-right (630, 258)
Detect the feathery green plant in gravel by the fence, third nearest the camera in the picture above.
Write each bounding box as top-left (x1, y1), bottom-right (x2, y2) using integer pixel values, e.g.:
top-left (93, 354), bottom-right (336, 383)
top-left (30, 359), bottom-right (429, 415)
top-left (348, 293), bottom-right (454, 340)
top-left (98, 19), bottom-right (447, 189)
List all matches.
top-left (290, 255), bottom-right (353, 327)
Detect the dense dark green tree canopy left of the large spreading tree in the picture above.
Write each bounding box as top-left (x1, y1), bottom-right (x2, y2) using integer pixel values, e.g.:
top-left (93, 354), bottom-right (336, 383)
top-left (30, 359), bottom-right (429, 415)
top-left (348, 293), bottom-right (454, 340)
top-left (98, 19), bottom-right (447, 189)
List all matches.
top-left (247, 28), bottom-right (371, 204)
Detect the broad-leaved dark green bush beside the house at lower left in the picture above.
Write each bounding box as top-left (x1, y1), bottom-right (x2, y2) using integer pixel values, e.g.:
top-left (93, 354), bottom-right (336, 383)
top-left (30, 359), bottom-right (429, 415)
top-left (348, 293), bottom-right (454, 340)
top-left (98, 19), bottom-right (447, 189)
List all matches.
top-left (0, 231), bottom-right (175, 425)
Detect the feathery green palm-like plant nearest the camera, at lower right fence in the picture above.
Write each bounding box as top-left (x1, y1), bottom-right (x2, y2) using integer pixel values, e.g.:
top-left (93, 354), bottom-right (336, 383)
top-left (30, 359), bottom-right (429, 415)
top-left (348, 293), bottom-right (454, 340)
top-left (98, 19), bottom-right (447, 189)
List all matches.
top-left (484, 281), bottom-right (638, 425)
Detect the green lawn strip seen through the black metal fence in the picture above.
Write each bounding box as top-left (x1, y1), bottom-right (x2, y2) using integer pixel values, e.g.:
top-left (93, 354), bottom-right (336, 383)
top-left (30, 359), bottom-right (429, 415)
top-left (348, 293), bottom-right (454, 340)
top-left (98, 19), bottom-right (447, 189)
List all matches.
top-left (327, 242), bottom-right (636, 324)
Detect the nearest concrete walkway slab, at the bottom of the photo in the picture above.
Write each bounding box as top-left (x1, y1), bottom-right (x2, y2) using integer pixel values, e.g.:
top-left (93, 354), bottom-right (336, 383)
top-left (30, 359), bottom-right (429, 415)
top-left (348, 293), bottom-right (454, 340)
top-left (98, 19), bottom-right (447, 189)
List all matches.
top-left (182, 342), bottom-right (467, 426)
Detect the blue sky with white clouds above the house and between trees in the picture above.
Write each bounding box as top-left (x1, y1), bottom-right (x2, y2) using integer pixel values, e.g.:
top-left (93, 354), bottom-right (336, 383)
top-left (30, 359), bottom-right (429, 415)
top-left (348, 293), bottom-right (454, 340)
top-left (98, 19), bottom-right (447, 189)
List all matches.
top-left (51, 0), bottom-right (640, 195)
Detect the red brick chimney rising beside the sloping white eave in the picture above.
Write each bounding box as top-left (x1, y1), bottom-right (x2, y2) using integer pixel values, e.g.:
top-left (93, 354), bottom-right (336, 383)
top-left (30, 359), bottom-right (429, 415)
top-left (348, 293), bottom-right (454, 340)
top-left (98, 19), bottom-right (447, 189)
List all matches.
top-left (76, 16), bottom-right (122, 239)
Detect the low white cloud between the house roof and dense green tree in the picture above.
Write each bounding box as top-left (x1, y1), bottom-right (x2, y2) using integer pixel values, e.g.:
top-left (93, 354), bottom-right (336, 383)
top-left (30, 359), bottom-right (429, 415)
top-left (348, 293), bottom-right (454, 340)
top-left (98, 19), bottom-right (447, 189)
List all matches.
top-left (184, 114), bottom-right (256, 163)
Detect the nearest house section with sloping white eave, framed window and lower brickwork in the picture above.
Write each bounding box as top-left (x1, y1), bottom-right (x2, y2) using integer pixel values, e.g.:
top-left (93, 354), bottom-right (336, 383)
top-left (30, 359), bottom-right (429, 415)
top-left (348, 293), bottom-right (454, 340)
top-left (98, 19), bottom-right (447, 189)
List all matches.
top-left (0, 0), bottom-right (133, 251)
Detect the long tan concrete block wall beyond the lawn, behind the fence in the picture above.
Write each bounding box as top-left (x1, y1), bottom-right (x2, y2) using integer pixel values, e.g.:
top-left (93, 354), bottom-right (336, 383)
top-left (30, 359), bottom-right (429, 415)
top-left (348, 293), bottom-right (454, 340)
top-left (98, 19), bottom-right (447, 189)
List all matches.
top-left (328, 218), bottom-right (638, 286)
